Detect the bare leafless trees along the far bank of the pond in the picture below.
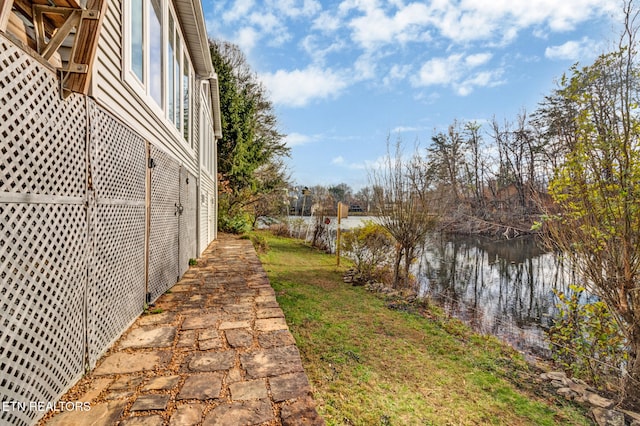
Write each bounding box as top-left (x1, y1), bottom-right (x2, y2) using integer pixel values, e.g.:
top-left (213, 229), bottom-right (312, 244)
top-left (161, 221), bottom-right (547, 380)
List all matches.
top-left (282, 106), bottom-right (567, 237)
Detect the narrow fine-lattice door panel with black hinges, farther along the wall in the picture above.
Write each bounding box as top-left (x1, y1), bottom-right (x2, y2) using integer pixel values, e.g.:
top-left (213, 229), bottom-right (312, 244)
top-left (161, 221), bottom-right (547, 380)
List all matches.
top-left (148, 145), bottom-right (180, 301)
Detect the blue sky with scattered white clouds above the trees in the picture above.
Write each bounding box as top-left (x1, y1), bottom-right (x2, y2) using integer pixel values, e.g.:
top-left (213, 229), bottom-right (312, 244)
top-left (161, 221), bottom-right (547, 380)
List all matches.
top-left (203, 0), bottom-right (621, 190)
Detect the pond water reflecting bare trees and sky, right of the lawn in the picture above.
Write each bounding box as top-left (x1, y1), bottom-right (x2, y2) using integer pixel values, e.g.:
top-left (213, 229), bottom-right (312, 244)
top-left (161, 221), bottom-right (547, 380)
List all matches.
top-left (416, 235), bottom-right (575, 357)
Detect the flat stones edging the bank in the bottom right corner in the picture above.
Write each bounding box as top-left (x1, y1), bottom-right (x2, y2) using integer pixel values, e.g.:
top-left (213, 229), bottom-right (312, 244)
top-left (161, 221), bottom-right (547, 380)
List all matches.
top-left (540, 371), bottom-right (640, 426)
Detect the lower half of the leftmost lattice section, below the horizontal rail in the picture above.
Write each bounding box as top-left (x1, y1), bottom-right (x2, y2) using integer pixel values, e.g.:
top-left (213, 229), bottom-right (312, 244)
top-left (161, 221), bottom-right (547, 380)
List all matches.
top-left (0, 203), bottom-right (86, 425)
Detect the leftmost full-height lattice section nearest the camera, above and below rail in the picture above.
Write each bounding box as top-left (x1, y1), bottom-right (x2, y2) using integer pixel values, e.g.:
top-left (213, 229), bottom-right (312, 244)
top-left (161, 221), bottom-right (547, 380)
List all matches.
top-left (0, 37), bottom-right (87, 425)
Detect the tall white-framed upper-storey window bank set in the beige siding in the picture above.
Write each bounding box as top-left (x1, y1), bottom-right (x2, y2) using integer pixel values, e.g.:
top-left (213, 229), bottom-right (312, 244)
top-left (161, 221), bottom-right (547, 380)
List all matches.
top-left (124, 0), bottom-right (194, 148)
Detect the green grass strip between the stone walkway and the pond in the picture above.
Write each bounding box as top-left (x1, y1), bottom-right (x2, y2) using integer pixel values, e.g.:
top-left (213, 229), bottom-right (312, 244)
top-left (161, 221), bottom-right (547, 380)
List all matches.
top-left (252, 234), bottom-right (591, 425)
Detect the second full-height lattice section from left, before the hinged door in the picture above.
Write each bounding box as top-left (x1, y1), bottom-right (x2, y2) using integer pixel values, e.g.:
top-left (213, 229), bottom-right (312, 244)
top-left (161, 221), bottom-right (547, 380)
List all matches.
top-left (87, 103), bottom-right (147, 367)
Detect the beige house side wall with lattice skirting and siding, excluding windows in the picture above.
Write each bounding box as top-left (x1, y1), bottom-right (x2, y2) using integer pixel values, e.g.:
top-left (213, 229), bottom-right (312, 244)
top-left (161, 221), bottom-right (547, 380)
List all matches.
top-left (0, 1), bottom-right (217, 425)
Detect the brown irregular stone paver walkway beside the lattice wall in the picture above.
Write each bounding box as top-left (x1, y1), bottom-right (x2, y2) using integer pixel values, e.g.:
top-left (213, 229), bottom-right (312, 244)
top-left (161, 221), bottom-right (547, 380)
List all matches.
top-left (42, 235), bottom-right (324, 426)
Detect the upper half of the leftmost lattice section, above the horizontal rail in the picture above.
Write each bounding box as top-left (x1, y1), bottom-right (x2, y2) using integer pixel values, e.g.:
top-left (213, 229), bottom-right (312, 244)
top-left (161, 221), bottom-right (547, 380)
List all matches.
top-left (0, 37), bottom-right (86, 197)
